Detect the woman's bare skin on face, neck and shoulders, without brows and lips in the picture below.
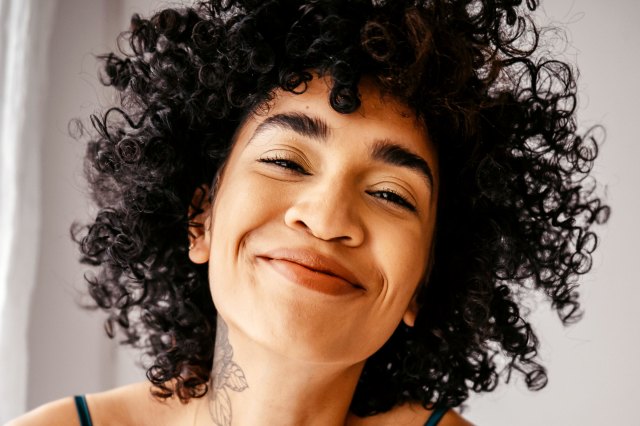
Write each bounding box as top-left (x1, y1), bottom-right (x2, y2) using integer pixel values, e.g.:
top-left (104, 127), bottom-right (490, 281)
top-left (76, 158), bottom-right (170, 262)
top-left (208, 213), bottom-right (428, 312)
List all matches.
top-left (10, 78), bottom-right (469, 426)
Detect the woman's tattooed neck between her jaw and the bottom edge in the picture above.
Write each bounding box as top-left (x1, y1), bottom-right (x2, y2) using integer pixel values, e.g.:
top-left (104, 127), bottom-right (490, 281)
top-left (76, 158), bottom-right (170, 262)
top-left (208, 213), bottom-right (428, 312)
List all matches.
top-left (196, 316), bottom-right (364, 426)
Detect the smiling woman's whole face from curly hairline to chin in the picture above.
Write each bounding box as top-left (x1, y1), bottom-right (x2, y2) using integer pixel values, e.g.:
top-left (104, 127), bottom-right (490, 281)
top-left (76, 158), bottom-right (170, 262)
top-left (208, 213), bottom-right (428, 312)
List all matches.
top-left (192, 78), bottom-right (438, 363)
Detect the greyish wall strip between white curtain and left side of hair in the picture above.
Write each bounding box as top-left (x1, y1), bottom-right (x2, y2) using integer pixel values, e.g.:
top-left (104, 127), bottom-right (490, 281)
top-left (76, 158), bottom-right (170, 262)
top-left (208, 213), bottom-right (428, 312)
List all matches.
top-left (28, 0), bottom-right (140, 407)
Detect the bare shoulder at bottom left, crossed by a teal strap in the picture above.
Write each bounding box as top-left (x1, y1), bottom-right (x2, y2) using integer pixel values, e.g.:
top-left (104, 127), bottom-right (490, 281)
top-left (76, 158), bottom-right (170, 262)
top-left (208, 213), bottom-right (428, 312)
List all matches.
top-left (5, 382), bottom-right (187, 426)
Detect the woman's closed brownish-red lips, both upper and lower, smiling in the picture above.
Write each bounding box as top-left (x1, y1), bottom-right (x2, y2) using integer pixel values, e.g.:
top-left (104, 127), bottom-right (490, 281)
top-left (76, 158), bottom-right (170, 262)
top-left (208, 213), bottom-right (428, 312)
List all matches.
top-left (258, 248), bottom-right (364, 294)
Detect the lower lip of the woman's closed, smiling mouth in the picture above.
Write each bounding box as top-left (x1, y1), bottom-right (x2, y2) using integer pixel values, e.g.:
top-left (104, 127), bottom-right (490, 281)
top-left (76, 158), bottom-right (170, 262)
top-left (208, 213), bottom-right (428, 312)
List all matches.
top-left (259, 258), bottom-right (361, 296)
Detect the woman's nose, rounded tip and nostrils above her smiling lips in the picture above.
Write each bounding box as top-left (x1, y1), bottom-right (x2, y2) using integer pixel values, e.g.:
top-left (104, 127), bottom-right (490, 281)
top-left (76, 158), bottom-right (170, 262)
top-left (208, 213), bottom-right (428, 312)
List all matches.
top-left (284, 179), bottom-right (365, 247)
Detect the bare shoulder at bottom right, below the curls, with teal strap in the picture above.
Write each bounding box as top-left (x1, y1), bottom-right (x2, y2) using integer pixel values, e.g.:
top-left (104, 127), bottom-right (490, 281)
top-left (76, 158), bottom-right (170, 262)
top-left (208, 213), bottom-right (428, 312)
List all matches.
top-left (347, 404), bottom-right (473, 426)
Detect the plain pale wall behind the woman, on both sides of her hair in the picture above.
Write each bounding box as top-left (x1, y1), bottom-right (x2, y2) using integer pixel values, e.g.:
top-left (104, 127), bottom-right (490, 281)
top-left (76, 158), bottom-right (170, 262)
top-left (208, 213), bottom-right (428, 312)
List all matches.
top-left (22, 0), bottom-right (640, 426)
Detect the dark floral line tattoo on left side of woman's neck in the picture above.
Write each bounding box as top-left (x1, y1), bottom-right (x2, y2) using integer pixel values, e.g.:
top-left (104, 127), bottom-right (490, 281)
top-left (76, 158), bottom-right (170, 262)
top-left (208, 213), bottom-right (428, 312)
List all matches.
top-left (208, 316), bottom-right (249, 426)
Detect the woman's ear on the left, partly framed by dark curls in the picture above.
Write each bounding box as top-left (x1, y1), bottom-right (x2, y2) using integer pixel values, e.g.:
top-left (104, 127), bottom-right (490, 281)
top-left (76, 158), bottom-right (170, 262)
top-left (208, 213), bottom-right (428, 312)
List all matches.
top-left (189, 185), bottom-right (211, 264)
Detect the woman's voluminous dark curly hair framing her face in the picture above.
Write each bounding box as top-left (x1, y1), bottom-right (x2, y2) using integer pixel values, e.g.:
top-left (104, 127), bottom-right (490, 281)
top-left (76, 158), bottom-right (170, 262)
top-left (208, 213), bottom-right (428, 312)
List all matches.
top-left (74, 0), bottom-right (609, 415)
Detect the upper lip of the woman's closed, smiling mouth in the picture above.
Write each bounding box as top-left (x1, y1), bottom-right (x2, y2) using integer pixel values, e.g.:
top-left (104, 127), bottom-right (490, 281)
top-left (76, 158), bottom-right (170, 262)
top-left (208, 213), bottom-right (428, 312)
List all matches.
top-left (258, 248), bottom-right (364, 288)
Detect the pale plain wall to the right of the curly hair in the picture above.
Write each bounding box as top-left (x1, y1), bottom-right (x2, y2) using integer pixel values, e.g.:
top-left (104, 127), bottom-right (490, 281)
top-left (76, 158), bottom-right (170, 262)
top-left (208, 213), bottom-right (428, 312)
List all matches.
top-left (467, 0), bottom-right (640, 426)
